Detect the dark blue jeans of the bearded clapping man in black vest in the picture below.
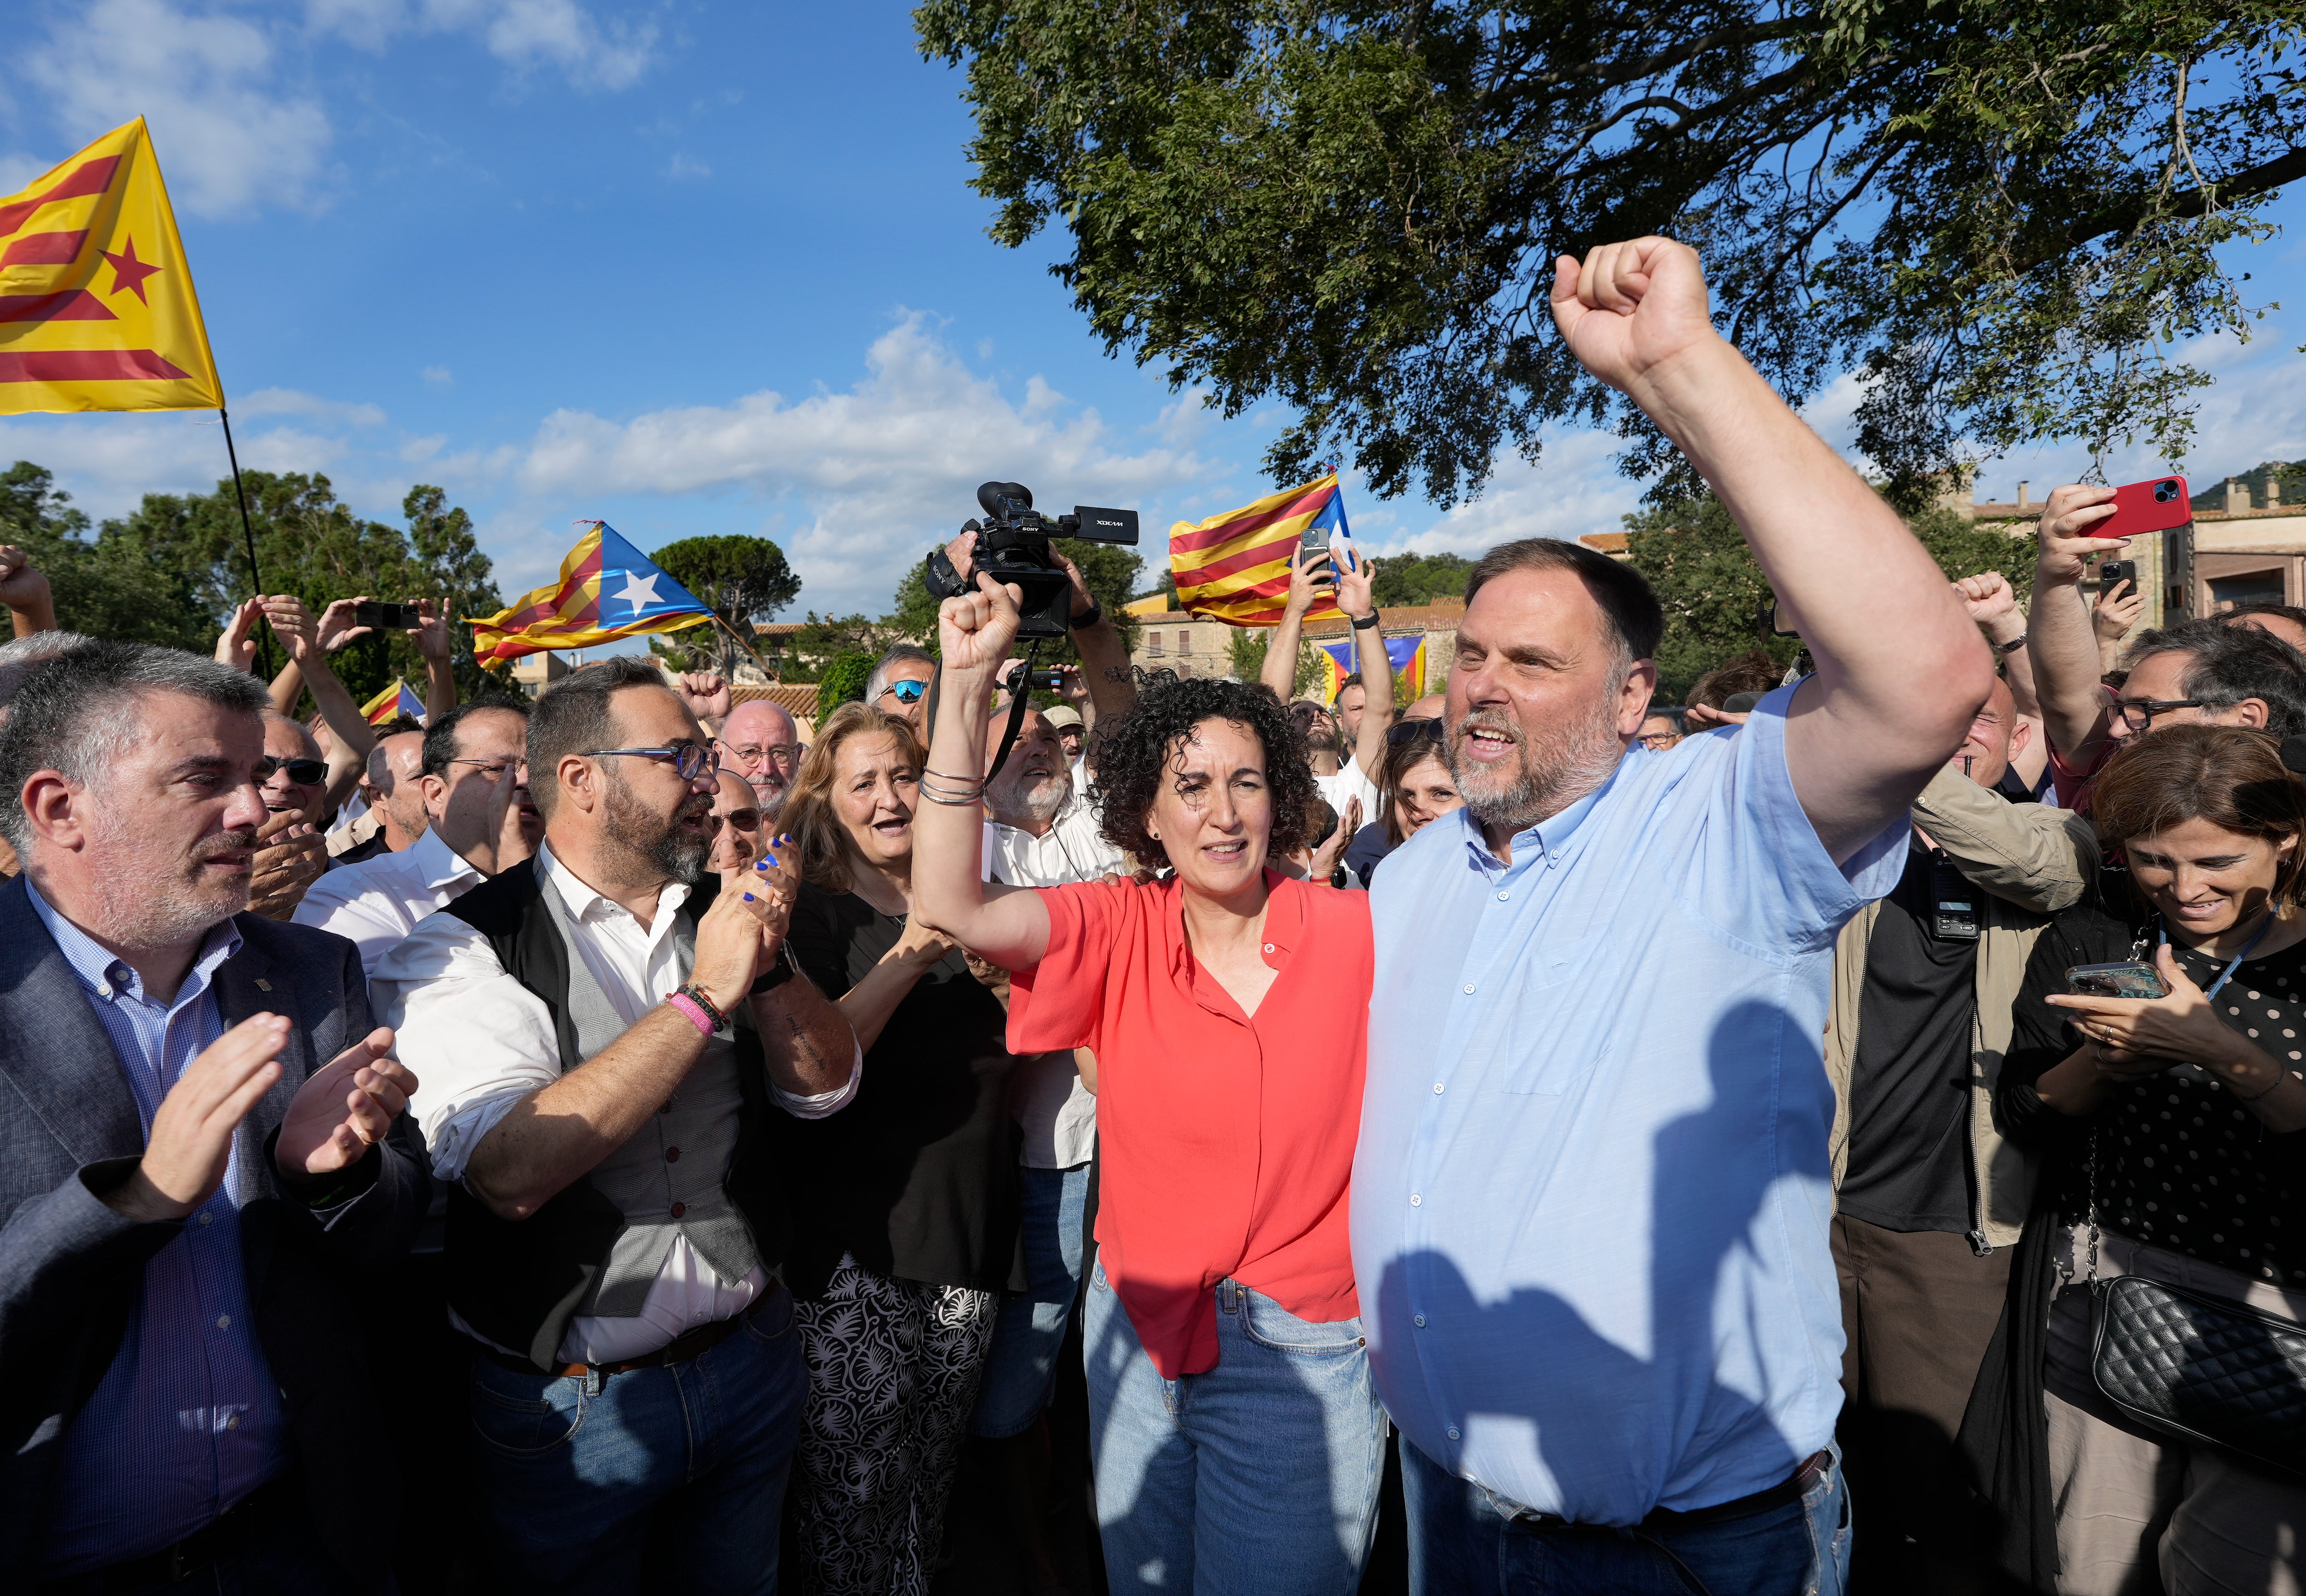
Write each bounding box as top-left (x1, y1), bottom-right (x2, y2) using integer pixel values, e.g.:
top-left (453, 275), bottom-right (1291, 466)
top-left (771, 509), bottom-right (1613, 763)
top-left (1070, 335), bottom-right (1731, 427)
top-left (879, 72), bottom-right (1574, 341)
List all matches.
top-left (473, 1285), bottom-right (809, 1596)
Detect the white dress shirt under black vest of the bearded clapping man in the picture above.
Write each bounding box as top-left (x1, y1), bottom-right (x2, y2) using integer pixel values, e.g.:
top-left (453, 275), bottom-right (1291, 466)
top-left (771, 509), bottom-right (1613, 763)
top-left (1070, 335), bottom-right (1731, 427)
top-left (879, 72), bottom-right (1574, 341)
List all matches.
top-left (369, 844), bottom-right (862, 1363)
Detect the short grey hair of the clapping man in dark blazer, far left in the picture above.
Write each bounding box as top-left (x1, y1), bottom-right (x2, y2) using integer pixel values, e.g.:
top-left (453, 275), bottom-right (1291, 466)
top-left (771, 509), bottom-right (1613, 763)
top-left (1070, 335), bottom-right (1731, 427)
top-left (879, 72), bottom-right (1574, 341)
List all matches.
top-left (0, 639), bottom-right (267, 854)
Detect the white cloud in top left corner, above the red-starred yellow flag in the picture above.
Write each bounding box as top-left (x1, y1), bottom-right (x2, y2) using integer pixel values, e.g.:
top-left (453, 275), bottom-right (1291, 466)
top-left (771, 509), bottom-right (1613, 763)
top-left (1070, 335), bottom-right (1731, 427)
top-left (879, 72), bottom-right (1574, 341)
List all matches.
top-left (14, 0), bottom-right (330, 217)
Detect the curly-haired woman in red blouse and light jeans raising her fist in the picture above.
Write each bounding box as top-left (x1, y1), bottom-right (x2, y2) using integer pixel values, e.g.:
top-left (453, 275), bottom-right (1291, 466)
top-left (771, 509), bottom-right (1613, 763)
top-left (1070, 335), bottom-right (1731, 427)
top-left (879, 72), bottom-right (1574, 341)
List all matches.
top-left (913, 576), bottom-right (1386, 1596)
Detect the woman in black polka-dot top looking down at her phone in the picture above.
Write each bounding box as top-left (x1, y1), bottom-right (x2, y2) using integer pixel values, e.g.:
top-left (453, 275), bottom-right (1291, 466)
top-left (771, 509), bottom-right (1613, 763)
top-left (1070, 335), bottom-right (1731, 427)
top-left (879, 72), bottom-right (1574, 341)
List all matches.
top-left (1962, 724), bottom-right (2306, 1596)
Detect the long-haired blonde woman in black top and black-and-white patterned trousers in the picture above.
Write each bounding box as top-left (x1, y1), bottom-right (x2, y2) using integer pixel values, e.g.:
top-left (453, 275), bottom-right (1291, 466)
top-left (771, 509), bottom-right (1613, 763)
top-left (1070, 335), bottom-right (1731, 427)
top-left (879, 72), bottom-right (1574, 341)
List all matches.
top-left (766, 703), bottom-right (1022, 1596)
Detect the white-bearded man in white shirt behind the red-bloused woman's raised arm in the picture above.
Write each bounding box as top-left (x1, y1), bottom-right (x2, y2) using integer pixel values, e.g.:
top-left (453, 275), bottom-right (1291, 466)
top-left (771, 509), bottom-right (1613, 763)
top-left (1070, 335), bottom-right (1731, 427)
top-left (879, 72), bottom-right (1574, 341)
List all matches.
top-left (969, 710), bottom-right (1128, 1589)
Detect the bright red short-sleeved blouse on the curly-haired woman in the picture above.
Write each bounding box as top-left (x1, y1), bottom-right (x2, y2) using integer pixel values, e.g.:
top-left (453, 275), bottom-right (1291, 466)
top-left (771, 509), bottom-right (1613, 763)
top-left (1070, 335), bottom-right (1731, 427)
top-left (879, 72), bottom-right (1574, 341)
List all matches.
top-left (1008, 870), bottom-right (1374, 1379)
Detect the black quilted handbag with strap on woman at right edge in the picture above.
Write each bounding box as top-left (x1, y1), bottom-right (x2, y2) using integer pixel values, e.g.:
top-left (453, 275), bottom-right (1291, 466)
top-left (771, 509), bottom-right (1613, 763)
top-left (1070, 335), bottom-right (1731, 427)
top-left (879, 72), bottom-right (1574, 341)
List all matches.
top-left (2089, 1135), bottom-right (2306, 1478)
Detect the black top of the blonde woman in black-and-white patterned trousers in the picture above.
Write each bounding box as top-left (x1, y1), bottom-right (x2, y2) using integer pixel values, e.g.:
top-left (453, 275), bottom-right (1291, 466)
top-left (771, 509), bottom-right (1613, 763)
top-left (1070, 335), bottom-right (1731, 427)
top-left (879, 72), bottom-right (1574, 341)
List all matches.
top-left (777, 884), bottom-right (1024, 1299)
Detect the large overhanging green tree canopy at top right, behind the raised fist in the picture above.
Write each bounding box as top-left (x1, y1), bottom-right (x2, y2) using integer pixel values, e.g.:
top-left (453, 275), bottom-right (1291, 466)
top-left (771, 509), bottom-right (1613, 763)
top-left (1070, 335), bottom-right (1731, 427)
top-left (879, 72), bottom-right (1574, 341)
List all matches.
top-left (913, 0), bottom-right (2306, 507)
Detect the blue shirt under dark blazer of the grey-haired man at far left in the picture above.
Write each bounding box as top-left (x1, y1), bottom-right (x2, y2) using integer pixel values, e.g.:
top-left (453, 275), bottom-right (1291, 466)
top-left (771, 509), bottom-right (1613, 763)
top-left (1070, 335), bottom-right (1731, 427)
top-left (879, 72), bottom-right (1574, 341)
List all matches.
top-left (25, 881), bottom-right (288, 1578)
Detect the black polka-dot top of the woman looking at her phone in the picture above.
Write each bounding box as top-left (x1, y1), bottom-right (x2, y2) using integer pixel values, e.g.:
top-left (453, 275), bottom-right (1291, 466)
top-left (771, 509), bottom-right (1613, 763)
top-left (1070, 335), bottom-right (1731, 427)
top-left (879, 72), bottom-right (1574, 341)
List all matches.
top-left (1997, 907), bottom-right (2306, 1287)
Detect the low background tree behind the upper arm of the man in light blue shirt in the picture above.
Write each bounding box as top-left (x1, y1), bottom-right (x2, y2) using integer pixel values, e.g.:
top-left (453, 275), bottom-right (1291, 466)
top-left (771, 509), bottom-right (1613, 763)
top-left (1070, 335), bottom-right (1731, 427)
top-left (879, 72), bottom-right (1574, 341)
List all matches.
top-left (1626, 493), bottom-right (2034, 703)
